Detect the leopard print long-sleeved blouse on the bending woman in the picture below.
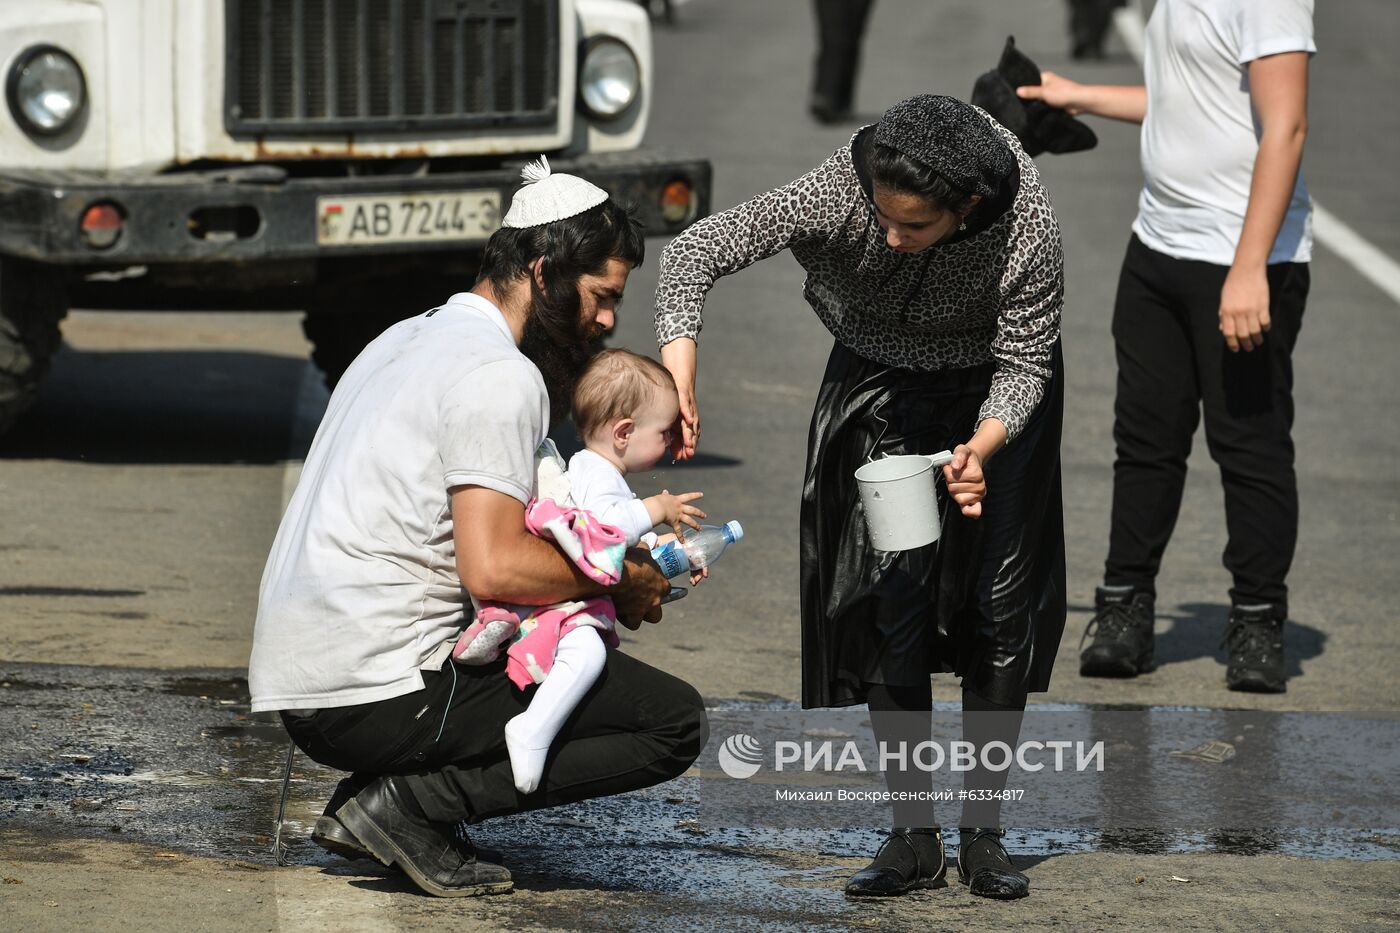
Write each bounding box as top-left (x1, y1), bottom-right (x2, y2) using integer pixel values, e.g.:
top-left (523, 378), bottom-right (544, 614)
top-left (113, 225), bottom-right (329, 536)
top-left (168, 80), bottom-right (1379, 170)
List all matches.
top-left (655, 113), bottom-right (1064, 438)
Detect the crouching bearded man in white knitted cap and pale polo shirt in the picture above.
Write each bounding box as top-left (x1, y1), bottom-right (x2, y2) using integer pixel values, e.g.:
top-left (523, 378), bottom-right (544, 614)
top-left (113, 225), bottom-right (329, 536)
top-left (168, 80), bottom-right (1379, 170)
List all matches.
top-left (248, 158), bottom-right (707, 897)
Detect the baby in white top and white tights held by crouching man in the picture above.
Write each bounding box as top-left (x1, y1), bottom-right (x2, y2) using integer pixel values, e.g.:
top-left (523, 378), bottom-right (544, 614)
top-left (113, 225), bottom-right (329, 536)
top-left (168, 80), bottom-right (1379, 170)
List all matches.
top-left (452, 350), bottom-right (706, 793)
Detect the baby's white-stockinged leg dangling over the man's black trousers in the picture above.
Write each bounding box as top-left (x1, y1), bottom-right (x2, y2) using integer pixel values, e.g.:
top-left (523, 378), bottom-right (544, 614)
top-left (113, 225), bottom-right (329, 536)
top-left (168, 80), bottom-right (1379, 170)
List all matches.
top-left (505, 625), bottom-right (608, 794)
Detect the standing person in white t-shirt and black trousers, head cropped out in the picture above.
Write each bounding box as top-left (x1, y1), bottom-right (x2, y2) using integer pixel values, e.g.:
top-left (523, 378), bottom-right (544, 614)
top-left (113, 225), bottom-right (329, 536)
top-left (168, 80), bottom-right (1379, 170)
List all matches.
top-left (1018, 0), bottom-right (1317, 693)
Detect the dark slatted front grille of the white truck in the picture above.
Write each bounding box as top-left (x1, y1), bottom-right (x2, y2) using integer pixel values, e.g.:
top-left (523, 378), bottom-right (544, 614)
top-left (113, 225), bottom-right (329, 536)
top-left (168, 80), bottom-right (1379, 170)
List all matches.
top-left (224, 0), bottom-right (559, 136)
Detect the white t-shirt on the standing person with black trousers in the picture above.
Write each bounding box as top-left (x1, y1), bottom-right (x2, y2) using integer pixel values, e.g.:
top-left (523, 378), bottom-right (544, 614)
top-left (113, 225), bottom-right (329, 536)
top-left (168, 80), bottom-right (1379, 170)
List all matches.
top-left (1133, 0), bottom-right (1317, 266)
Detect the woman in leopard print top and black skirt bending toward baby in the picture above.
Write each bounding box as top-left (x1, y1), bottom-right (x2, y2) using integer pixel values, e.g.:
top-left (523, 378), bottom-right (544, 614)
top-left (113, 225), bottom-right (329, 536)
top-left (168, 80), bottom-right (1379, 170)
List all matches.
top-left (657, 94), bottom-right (1065, 898)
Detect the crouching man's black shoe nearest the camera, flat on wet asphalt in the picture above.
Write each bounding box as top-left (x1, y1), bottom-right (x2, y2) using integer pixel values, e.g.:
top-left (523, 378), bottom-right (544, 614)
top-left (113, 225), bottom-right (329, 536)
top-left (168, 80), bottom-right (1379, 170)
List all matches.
top-left (337, 778), bottom-right (514, 898)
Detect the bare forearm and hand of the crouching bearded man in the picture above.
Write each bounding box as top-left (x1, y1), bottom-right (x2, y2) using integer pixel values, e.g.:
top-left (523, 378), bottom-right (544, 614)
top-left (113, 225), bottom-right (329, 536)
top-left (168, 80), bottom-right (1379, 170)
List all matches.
top-left (448, 486), bottom-right (671, 628)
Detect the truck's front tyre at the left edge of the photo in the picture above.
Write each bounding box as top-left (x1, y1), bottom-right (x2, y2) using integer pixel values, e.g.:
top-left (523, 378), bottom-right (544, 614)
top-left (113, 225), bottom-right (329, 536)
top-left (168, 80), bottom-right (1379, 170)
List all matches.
top-left (0, 259), bottom-right (69, 433)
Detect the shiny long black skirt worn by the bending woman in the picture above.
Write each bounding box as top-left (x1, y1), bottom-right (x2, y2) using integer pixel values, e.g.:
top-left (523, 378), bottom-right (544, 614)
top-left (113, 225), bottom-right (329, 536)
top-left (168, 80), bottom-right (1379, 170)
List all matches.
top-left (801, 343), bottom-right (1065, 709)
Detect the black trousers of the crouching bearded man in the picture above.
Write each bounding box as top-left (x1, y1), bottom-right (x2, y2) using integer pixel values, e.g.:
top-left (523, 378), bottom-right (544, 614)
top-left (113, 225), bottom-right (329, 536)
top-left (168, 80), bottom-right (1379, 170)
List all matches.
top-left (283, 651), bottom-right (710, 822)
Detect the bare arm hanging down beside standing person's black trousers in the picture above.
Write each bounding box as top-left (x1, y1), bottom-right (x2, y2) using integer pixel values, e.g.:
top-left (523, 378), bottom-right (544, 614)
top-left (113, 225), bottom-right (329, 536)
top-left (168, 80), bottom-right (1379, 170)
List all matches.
top-left (1219, 52), bottom-right (1308, 352)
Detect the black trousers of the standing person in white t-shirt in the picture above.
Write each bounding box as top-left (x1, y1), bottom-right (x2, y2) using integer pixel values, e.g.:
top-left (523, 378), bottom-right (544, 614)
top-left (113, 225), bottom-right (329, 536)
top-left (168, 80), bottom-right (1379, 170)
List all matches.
top-left (1103, 237), bottom-right (1309, 614)
